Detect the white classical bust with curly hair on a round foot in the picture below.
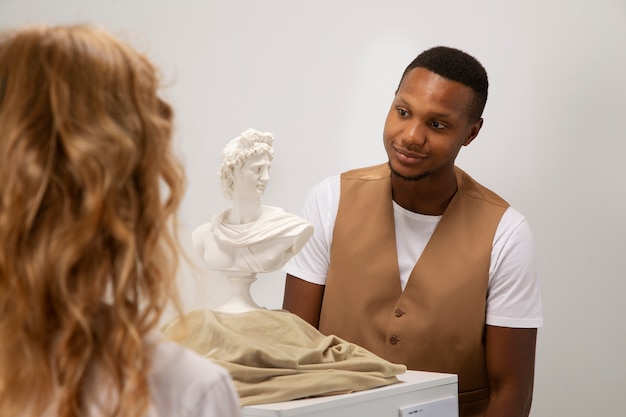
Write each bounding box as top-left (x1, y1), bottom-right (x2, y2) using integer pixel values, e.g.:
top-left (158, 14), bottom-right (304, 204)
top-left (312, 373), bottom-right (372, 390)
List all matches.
top-left (192, 129), bottom-right (313, 312)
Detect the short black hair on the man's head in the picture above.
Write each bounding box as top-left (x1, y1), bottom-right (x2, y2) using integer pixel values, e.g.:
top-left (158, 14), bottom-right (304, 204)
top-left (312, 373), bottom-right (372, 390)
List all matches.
top-left (398, 46), bottom-right (489, 121)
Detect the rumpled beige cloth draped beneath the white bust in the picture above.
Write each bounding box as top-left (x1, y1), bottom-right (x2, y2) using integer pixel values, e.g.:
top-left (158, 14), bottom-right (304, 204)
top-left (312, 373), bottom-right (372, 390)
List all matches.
top-left (163, 310), bottom-right (406, 405)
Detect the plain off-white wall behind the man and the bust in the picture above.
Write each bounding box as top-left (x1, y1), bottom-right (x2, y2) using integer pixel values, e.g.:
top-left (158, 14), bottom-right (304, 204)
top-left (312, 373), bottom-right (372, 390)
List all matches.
top-left (0, 0), bottom-right (626, 416)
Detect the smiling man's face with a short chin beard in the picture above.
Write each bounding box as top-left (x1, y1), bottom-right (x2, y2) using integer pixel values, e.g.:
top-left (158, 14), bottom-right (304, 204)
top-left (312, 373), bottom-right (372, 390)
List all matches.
top-left (383, 68), bottom-right (482, 180)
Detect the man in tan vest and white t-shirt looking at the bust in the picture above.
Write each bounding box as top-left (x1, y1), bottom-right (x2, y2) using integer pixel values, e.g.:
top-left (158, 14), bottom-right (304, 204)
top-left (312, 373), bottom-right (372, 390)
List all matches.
top-left (284, 47), bottom-right (543, 417)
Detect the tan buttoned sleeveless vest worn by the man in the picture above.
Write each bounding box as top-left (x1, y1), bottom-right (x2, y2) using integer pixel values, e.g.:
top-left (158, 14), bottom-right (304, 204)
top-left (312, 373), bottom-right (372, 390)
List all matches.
top-left (319, 164), bottom-right (508, 417)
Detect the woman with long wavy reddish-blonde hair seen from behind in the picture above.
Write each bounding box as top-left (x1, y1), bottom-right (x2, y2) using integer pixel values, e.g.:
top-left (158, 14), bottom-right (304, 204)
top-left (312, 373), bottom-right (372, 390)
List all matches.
top-left (0, 26), bottom-right (239, 417)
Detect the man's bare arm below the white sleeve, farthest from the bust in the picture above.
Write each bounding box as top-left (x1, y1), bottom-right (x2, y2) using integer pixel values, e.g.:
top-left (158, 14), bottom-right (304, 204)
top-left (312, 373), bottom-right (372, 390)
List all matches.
top-left (485, 325), bottom-right (537, 417)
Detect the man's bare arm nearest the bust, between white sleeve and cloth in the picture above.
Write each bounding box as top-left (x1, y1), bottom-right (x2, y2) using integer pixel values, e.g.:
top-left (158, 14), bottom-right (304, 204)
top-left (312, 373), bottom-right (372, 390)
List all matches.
top-left (283, 274), bottom-right (325, 328)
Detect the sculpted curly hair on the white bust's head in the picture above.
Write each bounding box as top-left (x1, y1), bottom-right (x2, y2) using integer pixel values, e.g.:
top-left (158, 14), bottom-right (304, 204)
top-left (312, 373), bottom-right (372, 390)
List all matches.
top-left (217, 129), bottom-right (274, 200)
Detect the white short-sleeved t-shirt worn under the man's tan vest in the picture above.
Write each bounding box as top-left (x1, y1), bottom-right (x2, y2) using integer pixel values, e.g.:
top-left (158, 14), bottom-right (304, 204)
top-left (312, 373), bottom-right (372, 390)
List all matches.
top-left (283, 175), bottom-right (543, 328)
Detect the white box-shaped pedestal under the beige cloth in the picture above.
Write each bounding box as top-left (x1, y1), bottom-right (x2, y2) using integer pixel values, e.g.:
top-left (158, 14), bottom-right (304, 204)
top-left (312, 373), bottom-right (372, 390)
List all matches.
top-left (241, 371), bottom-right (458, 417)
